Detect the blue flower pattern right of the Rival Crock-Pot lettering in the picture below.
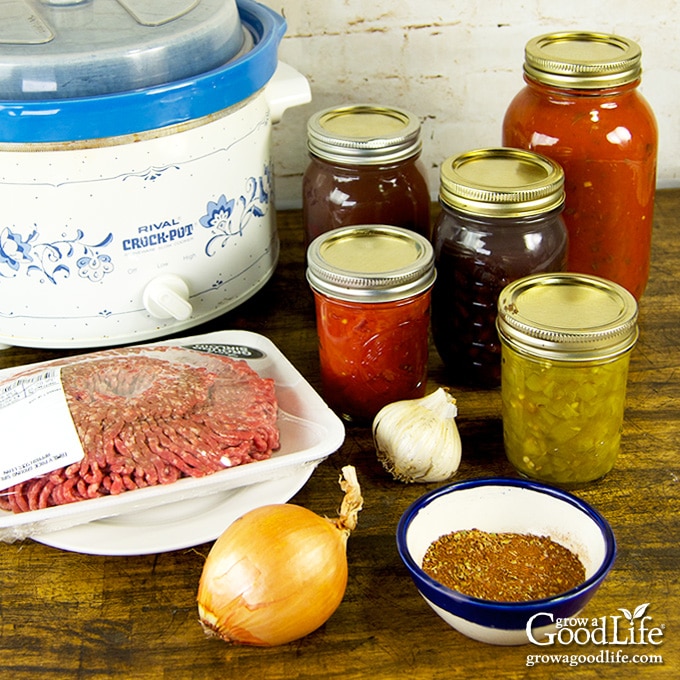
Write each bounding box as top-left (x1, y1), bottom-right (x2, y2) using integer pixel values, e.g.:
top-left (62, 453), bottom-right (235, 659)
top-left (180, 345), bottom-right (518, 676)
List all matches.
top-left (199, 166), bottom-right (271, 257)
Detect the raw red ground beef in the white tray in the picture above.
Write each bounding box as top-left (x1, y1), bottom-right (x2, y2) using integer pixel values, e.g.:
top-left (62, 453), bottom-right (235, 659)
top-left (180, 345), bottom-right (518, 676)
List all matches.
top-left (0, 346), bottom-right (279, 512)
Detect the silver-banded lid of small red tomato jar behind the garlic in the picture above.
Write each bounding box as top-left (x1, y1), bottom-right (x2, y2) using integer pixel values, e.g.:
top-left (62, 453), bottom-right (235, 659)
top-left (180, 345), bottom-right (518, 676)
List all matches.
top-left (307, 224), bottom-right (436, 302)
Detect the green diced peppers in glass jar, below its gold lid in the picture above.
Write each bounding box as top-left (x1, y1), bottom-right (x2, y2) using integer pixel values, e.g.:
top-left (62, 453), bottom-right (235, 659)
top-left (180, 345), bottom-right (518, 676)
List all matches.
top-left (502, 348), bottom-right (629, 484)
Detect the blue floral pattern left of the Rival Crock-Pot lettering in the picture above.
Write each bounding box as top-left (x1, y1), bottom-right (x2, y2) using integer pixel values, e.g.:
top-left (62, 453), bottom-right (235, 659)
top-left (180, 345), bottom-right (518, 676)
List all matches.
top-left (0, 227), bottom-right (114, 285)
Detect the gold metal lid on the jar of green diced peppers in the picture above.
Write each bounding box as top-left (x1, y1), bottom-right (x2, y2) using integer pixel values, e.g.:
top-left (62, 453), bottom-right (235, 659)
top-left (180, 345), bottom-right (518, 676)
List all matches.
top-left (496, 273), bottom-right (638, 361)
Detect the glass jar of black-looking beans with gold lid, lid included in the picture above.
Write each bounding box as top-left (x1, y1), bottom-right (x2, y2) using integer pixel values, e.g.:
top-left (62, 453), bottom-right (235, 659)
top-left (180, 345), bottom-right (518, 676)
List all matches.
top-left (432, 148), bottom-right (567, 388)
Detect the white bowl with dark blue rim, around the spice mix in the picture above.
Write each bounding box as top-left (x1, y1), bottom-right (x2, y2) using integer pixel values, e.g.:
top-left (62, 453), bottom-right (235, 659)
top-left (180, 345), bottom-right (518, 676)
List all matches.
top-left (397, 478), bottom-right (616, 645)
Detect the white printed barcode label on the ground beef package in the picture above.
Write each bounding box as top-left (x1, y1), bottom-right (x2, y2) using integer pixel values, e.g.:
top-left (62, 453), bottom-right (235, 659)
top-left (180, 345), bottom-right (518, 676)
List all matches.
top-left (0, 367), bottom-right (85, 490)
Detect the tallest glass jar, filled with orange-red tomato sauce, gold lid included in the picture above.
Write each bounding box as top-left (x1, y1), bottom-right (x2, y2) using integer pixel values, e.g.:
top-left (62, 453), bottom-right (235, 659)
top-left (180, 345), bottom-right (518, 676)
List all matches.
top-left (503, 32), bottom-right (658, 299)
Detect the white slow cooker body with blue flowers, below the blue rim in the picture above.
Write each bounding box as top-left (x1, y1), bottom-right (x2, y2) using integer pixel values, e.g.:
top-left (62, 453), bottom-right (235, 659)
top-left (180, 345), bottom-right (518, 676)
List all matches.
top-left (0, 92), bottom-right (279, 347)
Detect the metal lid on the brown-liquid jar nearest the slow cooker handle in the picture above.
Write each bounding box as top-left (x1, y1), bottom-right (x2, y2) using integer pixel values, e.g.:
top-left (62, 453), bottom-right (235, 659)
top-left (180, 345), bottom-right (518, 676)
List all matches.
top-left (307, 104), bottom-right (422, 165)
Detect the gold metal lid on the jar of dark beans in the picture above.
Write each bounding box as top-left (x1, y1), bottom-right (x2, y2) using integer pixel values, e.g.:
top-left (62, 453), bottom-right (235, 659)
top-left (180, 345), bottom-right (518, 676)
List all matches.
top-left (439, 147), bottom-right (564, 217)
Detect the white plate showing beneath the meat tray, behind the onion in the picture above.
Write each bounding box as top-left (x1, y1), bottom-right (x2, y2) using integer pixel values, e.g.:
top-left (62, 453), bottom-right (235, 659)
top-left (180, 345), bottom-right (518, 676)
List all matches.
top-left (33, 465), bottom-right (316, 555)
